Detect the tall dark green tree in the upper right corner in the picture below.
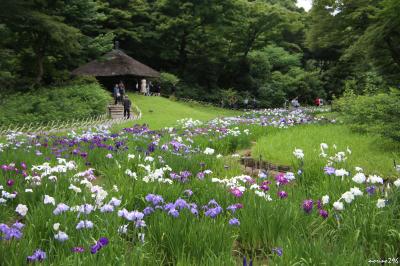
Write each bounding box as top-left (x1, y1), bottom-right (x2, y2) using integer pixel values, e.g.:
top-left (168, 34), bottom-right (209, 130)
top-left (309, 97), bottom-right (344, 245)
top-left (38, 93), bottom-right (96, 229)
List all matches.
top-left (306, 0), bottom-right (400, 96)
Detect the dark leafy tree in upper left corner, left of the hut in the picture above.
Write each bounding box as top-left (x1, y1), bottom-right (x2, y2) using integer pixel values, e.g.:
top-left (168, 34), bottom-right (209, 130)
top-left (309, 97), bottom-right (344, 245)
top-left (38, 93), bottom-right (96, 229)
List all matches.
top-left (0, 0), bottom-right (113, 86)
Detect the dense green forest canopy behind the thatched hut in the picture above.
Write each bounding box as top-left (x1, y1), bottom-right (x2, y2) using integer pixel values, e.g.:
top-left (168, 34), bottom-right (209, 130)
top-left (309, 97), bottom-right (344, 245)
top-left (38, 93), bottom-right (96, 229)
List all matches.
top-left (0, 0), bottom-right (400, 106)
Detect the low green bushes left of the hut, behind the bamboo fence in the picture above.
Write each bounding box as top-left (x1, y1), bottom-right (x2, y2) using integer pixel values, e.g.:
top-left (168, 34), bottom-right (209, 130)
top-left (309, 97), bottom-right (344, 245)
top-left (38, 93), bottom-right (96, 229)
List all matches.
top-left (0, 81), bottom-right (111, 125)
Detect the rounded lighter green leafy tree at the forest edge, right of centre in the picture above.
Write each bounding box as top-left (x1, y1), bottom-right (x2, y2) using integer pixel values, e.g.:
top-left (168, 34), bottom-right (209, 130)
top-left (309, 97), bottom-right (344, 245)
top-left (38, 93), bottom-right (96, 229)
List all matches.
top-left (249, 45), bottom-right (327, 107)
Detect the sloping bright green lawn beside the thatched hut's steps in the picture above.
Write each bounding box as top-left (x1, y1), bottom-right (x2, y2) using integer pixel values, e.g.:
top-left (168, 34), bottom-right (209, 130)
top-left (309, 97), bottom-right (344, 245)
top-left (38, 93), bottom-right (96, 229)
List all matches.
top-left (114, 93), bottom-right (241, 130)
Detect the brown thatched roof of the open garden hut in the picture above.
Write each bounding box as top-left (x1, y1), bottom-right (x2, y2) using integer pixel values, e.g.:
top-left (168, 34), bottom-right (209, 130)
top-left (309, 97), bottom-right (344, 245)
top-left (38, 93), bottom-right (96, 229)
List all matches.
top-left (72, 50), bottom-right (160, 78)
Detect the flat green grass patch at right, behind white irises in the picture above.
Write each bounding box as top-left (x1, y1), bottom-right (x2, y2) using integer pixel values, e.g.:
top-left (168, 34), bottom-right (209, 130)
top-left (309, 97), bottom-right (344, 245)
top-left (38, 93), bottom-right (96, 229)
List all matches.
top-left (252, 124), bottom-right (400, 178)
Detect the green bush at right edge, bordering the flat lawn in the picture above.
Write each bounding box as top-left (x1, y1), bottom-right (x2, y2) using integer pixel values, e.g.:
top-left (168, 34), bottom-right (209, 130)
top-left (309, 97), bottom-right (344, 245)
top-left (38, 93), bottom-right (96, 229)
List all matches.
top-left (335, 90), bottom-right (400, 141)
